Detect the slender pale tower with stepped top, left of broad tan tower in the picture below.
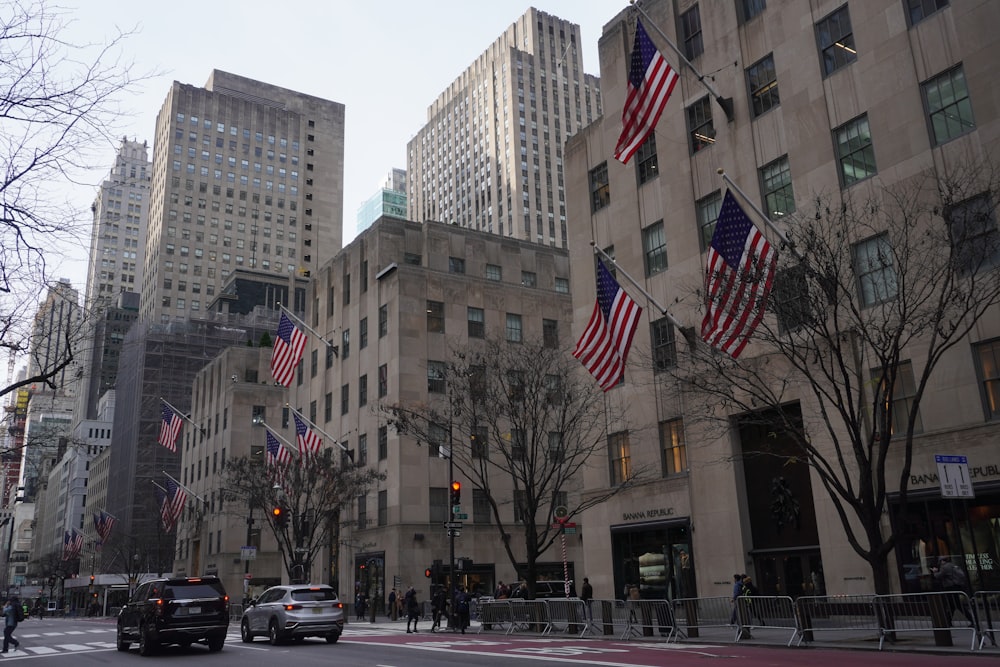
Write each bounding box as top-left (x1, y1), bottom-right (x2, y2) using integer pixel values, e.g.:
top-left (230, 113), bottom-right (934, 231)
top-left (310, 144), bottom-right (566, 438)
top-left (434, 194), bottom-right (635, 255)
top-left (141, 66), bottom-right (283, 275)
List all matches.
top-left (85, 138), bottom-right (152, 308)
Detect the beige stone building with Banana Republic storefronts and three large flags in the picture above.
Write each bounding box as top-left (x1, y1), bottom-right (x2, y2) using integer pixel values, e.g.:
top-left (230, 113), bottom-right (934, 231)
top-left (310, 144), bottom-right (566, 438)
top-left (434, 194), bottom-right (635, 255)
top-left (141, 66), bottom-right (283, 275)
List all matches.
top-left (566, 0), bottom-right (1000, 597)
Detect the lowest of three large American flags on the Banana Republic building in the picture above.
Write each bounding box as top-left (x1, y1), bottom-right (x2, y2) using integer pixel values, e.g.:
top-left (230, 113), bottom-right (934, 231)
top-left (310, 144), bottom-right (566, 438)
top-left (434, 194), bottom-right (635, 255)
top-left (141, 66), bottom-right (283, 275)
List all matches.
top-left (573, 260), bottom-right (642, 391)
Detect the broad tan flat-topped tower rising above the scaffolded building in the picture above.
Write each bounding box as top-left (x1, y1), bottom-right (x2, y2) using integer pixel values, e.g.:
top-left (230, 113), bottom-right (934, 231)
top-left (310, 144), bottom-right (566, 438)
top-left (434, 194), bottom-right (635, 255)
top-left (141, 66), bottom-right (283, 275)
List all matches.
top-left (139, 70), bottom-right (344, 323)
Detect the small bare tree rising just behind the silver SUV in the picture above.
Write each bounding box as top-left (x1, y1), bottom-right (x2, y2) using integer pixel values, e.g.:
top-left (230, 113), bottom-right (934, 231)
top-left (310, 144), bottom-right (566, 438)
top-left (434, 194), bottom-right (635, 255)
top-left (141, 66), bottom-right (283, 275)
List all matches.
top-left (225, 448), bottom-right (385, 583)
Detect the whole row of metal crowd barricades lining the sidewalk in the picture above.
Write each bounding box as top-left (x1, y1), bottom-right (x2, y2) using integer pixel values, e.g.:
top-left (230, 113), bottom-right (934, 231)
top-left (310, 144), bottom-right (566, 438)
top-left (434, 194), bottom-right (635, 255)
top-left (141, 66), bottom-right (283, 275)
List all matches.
top-left (477, 591), bottom-right (1000, 650)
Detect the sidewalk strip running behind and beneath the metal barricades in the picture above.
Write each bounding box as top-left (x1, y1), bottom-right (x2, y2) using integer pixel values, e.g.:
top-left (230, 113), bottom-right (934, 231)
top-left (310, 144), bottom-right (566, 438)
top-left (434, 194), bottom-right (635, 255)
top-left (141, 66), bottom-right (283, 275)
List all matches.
top-left (345, 616), bottom-right (1000, 658)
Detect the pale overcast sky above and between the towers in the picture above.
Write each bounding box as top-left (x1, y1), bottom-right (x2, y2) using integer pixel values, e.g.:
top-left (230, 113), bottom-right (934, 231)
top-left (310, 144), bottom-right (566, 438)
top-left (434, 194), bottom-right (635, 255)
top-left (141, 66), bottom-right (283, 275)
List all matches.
top-left (58, 0), bottom-right (628, 294)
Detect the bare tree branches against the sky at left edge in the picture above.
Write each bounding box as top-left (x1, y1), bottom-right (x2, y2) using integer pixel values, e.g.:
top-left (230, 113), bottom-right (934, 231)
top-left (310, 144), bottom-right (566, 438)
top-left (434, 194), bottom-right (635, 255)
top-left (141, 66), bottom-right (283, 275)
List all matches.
top-left (0, 0), bottom-right (147, 395)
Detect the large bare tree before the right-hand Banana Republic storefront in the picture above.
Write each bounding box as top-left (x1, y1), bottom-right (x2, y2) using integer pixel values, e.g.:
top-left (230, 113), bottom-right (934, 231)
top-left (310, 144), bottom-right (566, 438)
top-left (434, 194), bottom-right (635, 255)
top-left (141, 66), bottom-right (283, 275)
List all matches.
top-left (672, 162), bottom-right (1000, 593)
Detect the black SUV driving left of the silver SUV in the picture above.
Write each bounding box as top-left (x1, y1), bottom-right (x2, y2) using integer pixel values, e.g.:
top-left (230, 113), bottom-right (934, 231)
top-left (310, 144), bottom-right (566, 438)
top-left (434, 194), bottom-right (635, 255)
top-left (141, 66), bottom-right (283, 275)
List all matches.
top-left (118, 577), bottom-right (229, 655)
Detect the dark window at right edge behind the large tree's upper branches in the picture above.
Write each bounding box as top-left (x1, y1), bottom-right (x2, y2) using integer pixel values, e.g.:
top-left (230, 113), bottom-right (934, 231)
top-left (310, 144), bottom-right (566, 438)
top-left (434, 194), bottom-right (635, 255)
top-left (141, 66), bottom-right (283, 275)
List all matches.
top-left (944, 193), bottom-right (1000, 275)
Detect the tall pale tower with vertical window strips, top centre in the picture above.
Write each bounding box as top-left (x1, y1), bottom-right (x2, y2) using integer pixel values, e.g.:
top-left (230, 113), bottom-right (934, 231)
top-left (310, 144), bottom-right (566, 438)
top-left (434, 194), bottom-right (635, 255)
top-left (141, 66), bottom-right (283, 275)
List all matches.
top-left (407, 8), bottom-right (602, 248)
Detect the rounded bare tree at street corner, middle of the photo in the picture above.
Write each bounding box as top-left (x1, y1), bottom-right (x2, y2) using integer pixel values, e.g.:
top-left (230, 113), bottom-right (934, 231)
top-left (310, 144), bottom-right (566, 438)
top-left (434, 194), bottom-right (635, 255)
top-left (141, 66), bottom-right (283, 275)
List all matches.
top-left (381, 339), bottom-right (641, 597)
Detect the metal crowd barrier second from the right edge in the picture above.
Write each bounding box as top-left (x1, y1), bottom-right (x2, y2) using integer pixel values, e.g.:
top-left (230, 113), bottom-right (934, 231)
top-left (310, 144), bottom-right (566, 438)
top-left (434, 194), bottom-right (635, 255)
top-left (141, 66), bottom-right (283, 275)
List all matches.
top-left (873, 591), bottom-right (980, 650)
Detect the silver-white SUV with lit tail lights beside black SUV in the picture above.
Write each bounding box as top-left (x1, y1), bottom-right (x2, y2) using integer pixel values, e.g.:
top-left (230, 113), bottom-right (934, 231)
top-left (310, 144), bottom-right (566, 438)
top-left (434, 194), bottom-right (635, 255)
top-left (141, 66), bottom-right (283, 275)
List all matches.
top-left (240, 584), bottom-right (344, 646)
